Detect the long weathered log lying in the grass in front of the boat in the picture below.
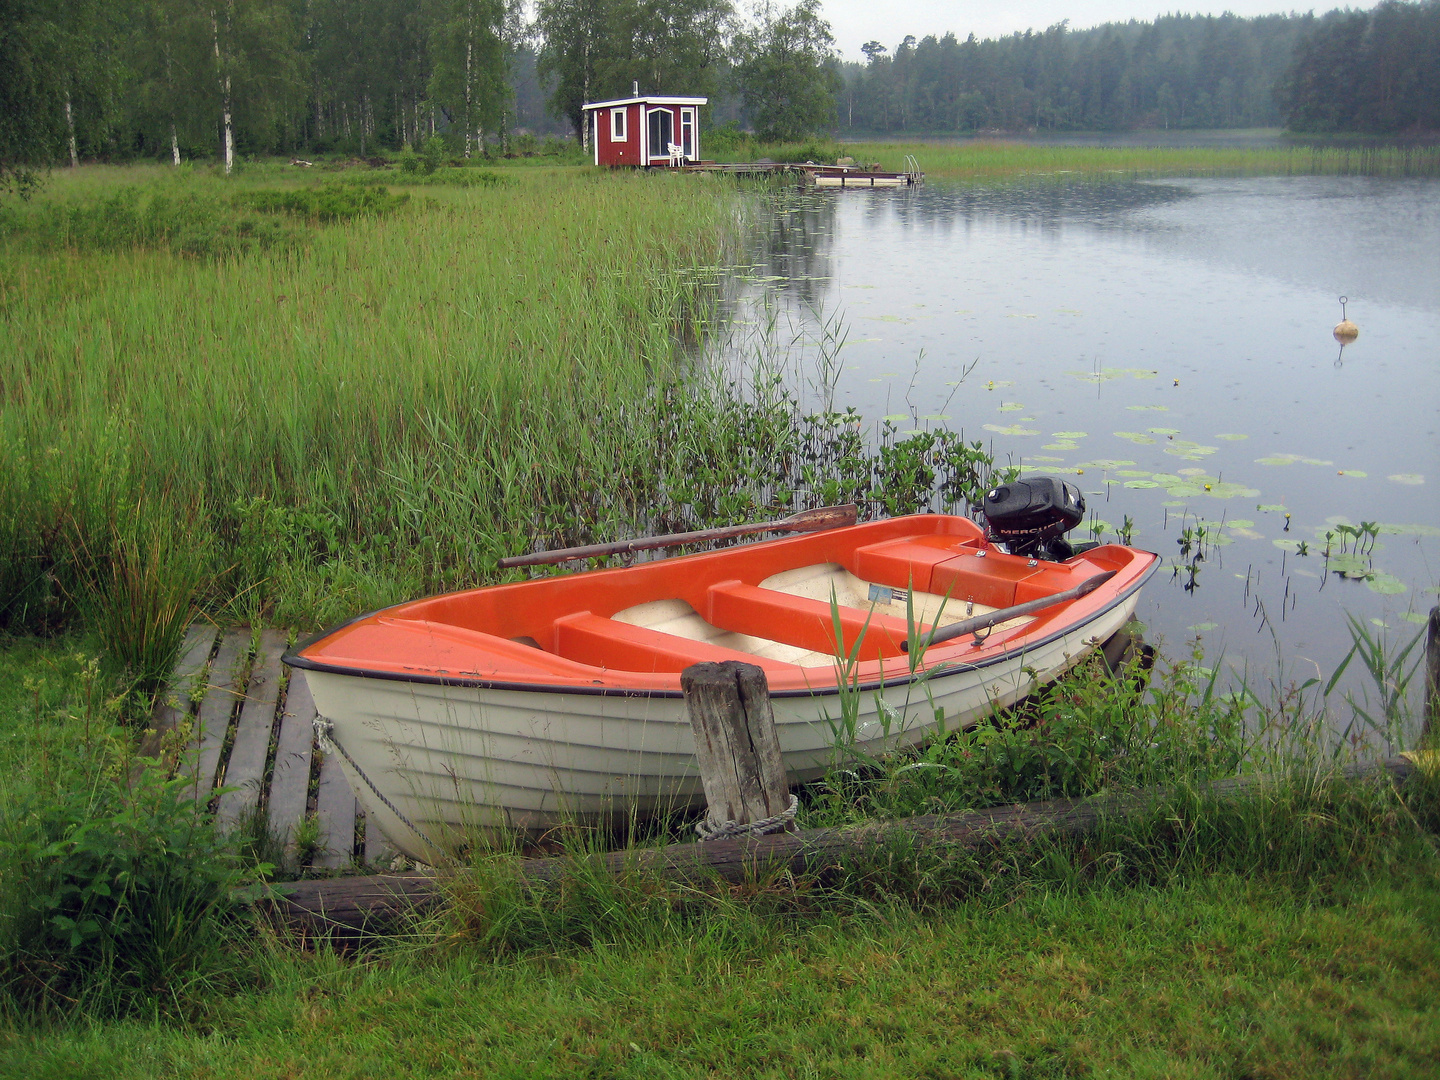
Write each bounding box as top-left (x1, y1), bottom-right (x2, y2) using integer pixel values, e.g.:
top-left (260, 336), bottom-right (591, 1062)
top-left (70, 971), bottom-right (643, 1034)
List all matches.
top-left (266, 757), bottom-right (1416, 940)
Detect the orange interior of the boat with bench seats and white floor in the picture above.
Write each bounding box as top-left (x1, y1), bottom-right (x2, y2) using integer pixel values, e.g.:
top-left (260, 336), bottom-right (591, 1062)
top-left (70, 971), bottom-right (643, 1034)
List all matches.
top-left (298, 514), bottom-right (1156, 693)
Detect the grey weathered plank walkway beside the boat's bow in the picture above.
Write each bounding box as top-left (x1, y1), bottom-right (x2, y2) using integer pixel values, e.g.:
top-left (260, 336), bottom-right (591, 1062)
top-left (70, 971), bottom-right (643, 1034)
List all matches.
top-left (152, 624), bottom-right (396, 870)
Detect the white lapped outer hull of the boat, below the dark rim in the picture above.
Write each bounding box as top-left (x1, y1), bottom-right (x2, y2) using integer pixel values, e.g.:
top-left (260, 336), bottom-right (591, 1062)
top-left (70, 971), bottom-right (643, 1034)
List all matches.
top-left (297, 590), bottom-right (1139, 863)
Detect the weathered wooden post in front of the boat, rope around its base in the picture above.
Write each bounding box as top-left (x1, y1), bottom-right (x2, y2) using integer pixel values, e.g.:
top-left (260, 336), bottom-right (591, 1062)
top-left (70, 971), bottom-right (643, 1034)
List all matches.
top-left (680, 660), bottom-right (795, 829)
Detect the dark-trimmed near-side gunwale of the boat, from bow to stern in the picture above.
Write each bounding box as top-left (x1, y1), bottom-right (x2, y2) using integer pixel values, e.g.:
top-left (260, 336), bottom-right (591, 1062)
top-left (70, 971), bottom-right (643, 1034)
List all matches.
top-left (281, 549), bottom-right (1161, 698)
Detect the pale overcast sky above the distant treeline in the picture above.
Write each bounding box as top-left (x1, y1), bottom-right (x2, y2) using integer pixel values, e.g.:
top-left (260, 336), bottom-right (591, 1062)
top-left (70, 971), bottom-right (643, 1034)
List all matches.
top-left (817, 0), bottom-right (1319, 60)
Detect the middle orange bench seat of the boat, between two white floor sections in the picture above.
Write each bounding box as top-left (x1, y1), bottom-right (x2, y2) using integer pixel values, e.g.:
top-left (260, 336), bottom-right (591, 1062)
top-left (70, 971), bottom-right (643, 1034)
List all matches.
top-left (703, 580), bottom-right (909, 660)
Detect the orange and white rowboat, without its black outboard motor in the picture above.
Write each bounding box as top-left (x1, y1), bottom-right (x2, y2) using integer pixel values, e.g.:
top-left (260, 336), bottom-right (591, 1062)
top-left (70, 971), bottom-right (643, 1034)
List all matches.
top-left (285, 514), bottom-right (1158, 863)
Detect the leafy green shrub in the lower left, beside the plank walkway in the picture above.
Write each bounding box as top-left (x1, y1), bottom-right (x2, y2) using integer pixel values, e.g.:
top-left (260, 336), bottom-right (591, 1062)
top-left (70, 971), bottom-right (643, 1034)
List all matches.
top-left (0, 754), bottom-right (263, 1015)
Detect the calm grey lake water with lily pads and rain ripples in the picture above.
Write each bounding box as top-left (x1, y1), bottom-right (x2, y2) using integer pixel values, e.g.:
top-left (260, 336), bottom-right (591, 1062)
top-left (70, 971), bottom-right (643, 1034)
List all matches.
top-left (720, 177), bottom-right (1440, 711)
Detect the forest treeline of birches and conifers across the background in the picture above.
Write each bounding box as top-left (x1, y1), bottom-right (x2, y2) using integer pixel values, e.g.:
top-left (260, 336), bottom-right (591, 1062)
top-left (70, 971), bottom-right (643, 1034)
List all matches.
top-left (0, 0), bottom-right (1440, 190)
